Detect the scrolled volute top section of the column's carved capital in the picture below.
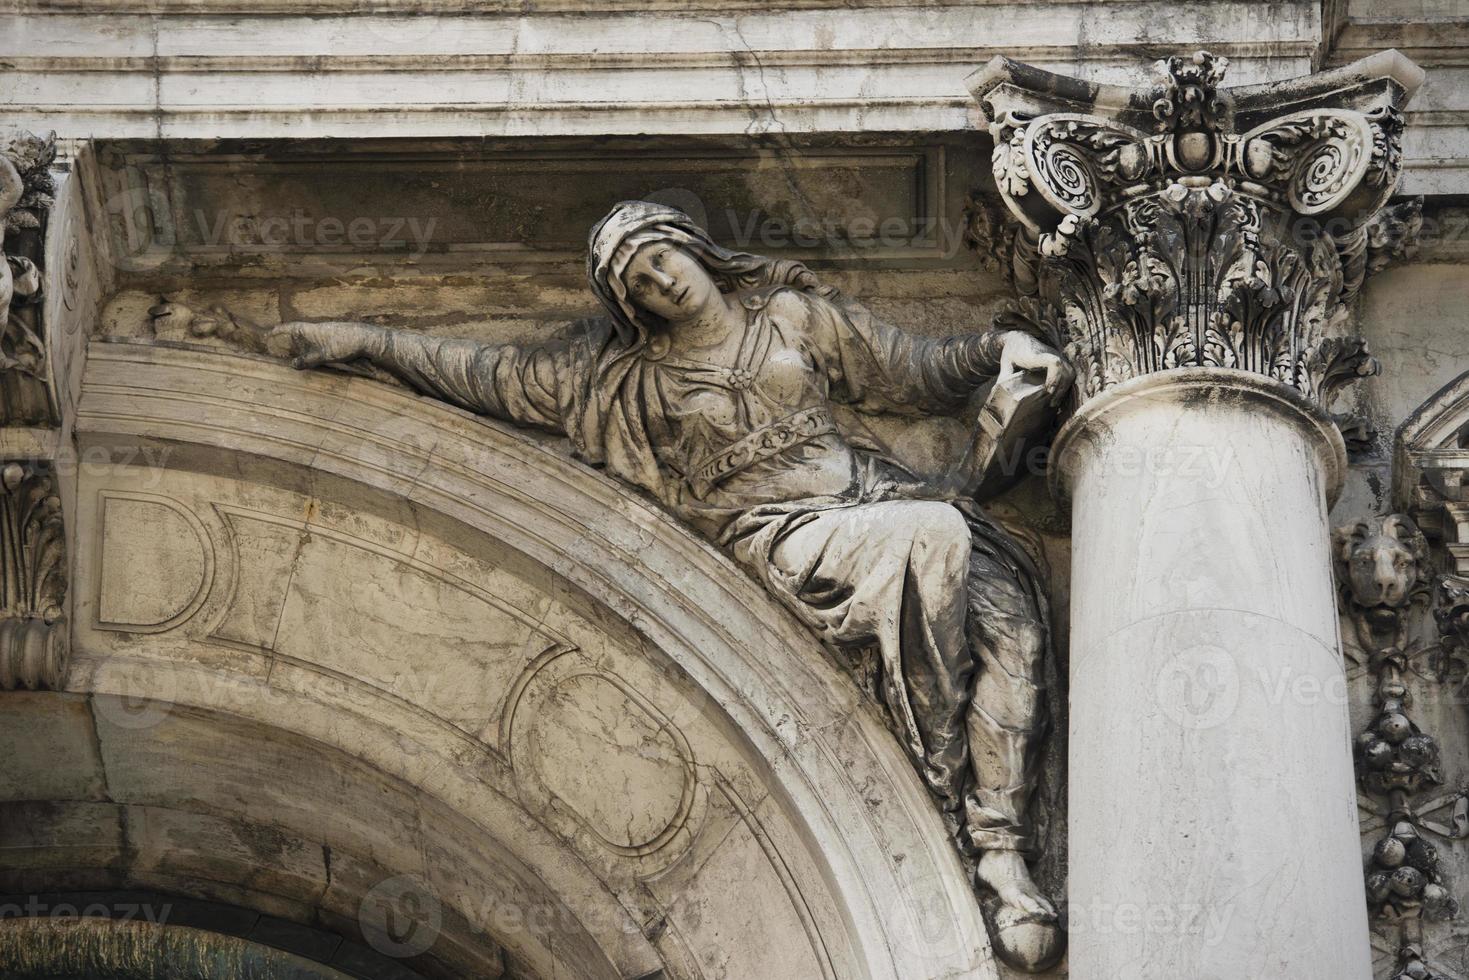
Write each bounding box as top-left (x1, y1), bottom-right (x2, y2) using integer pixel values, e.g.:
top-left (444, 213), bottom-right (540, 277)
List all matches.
top-left (971, 51), bottom-right (1416, 234)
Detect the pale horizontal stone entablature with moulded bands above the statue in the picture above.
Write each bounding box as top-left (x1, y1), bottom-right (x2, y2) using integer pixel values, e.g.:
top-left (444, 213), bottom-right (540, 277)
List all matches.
top-left (0, 0), bottom-right (1321, 138)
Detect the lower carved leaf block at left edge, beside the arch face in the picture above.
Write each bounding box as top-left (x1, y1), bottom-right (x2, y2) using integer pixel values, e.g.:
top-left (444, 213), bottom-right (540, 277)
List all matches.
top-left (0, 463), bottom-right (68, 691)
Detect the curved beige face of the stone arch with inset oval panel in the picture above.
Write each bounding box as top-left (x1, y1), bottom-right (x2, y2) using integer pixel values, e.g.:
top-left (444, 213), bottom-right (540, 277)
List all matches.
top-left (72, 344), bottom-right (997, 979)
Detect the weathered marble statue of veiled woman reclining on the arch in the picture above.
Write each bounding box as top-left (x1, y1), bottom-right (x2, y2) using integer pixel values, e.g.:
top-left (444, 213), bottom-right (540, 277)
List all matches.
top-left (272, 201), bottom-right (1071, 970)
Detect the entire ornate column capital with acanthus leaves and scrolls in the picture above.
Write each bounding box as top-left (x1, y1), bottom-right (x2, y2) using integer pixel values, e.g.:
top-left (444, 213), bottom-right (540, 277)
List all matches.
top-left (970, 51), bottom-right (1421, 407)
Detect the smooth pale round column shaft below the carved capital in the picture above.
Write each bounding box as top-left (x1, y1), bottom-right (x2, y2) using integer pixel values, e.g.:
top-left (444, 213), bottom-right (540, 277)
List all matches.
top-left (1053, 367), bottom-right (1371, 980)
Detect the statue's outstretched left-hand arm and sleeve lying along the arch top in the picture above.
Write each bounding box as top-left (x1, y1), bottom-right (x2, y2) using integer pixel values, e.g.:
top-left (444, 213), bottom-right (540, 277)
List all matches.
top-left (267, 322), bottom-right (571, 432)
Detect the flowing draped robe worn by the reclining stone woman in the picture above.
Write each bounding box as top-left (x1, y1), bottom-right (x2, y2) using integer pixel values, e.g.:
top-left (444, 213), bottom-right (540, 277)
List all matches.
top-left (382, 285), bottom-right (1047, 852)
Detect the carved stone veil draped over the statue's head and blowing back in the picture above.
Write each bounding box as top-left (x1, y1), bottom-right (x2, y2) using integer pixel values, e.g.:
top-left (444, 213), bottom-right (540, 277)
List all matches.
top-left (586, 201), bottom-right (836, 347)
